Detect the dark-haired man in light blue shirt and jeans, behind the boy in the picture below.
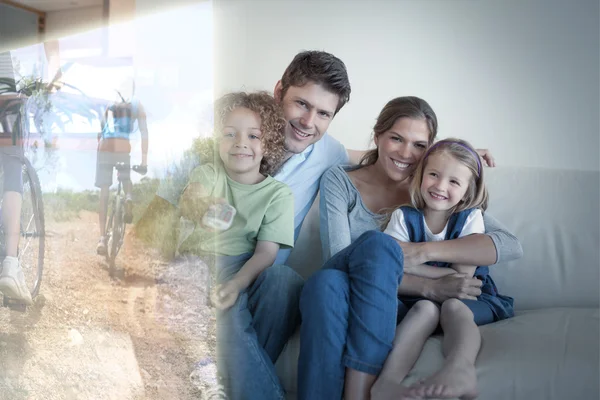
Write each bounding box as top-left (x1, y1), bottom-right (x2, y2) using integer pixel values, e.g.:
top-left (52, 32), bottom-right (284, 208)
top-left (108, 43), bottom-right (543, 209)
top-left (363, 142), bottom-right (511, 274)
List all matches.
top-left (142, 51), bottom-right (351, 400)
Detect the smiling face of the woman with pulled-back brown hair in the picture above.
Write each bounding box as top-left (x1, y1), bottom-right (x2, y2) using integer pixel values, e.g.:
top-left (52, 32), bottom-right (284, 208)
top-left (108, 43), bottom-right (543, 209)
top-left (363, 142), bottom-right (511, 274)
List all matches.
top-left (375, 117), bottom-right (429, 181)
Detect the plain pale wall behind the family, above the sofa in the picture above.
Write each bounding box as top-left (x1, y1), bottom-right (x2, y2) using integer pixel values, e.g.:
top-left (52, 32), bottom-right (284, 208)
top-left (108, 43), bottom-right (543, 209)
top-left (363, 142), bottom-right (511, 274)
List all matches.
top-left (213, 0), bottom-right (600, 170)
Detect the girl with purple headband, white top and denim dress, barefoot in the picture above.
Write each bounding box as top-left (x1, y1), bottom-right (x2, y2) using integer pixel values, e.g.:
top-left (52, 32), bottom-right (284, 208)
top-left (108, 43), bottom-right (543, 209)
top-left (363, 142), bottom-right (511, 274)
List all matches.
top-left (374, 139), bottom-right (513, 398)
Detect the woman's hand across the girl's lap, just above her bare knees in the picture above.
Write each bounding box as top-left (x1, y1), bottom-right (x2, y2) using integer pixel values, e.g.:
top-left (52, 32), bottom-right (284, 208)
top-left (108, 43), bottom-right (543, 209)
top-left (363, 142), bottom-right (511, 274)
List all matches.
top-left (425, 274), bottom-right (482, 303)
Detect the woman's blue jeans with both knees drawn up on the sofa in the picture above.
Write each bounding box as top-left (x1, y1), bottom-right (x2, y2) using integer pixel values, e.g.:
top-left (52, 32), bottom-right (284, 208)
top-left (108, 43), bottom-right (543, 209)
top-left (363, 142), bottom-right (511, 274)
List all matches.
top-left (298, 231), bottom-right (404, 400)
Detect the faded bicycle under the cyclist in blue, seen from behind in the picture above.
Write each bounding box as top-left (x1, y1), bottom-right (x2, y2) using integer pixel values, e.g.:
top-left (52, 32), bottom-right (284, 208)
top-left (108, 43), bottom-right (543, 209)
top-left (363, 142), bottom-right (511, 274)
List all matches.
top-left (105, 162), bottom-right (147, 277)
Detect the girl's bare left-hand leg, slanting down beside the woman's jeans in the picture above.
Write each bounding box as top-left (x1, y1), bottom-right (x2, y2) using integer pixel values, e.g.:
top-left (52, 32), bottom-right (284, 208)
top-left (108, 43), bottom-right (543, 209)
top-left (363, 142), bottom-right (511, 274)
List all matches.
top-left (371, 300), bottom-right (440, 400)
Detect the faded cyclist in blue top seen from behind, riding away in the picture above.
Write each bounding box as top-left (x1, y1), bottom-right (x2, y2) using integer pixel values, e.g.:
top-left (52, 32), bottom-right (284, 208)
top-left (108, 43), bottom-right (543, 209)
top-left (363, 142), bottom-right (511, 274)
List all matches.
top-left (96, 79), bottom-right (148, 255)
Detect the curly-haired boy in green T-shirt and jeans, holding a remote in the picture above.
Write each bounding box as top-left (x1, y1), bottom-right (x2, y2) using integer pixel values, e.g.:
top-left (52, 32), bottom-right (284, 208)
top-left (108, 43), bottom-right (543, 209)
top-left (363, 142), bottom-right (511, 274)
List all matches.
top-left (179, 92), bottom-right (294, 400)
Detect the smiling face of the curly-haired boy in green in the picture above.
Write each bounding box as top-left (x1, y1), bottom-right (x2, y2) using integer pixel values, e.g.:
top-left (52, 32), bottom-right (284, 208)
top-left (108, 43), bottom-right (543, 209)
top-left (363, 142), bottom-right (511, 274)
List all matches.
top-left (219, 107), bottom-right (263, 179)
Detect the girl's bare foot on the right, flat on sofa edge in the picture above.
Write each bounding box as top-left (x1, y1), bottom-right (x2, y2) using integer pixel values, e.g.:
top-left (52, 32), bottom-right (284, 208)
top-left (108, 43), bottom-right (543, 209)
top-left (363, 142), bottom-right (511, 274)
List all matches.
top-left (409, 362), bottom-right (479, 400)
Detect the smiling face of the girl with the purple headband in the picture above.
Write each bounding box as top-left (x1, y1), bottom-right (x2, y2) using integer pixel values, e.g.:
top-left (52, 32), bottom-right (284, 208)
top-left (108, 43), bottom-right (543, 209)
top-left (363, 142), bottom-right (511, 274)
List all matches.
top-left (421, 152), bottom-right (473, 211)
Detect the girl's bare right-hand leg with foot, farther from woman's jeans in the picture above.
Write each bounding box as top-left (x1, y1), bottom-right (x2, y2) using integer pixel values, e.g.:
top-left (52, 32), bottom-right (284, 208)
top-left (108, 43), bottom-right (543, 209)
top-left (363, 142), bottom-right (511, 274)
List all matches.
top-left (411, 299), bottom-right (493, 399)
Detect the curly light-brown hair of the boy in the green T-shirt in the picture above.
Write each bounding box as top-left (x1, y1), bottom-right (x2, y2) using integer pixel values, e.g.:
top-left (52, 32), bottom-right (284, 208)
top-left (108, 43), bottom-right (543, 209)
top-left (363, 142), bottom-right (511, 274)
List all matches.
top-left (214, 91), bottom-right (287, 175)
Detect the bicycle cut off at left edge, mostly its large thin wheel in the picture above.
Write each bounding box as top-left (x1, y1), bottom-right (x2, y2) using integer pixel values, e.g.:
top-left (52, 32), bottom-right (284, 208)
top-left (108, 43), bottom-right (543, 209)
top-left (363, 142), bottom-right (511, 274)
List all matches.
top-left (0, 153), bottom-right (46, 311)
